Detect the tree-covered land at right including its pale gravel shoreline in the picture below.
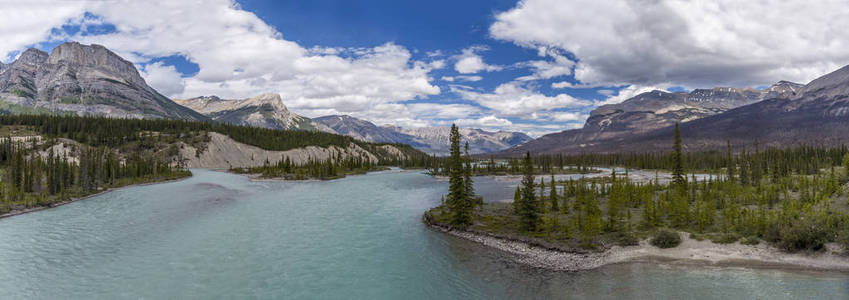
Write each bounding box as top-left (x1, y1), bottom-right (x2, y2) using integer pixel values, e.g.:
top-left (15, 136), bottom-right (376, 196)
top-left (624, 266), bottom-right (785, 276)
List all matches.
top-left (423, 126), bottom-right (849, 271)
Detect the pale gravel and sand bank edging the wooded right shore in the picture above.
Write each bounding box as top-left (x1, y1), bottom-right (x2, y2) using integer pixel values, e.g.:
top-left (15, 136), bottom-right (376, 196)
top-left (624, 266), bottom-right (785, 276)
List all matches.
top-left (428, 224), bottom-right (849, 272)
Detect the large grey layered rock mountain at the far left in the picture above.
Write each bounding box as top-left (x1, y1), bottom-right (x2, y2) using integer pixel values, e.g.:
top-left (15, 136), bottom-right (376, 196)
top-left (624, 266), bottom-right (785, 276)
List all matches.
top-left (0, 42), bottom-right (207, 120)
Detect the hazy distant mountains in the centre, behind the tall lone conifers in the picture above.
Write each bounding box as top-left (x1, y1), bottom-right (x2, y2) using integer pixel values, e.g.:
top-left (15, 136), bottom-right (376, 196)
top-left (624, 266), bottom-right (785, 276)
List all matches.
top-left (314, 116), bottom-right (531, 155)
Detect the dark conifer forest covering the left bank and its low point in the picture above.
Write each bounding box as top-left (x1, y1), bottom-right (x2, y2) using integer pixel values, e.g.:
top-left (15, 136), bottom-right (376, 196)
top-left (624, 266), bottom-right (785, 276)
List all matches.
top-left (0, 115), bottom-right (432, 214)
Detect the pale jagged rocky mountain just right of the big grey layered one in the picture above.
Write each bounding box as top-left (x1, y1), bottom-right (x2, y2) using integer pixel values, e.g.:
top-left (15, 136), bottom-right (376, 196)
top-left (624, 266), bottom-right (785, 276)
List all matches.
top-left (174, 94), bottom-right (336, 133)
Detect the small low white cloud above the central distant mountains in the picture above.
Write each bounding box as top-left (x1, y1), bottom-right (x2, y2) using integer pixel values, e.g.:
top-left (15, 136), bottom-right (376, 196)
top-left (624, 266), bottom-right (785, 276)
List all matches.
top-left (451, 81), bottom-right (592, 119)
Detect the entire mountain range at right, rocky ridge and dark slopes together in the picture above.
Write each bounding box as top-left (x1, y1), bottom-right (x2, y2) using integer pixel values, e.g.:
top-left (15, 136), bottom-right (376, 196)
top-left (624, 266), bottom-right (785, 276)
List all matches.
top-left (498, 66), bottom-right (849, 155)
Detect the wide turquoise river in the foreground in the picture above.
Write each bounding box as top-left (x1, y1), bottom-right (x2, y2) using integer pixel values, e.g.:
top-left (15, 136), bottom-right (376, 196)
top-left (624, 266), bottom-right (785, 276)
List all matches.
top-left (0, 170), bottom-right (849, 299)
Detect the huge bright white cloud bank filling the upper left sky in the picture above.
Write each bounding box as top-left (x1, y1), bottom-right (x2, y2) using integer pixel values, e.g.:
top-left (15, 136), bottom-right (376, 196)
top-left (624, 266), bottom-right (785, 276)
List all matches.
top-left (0, 0), bottom-right (445, 116)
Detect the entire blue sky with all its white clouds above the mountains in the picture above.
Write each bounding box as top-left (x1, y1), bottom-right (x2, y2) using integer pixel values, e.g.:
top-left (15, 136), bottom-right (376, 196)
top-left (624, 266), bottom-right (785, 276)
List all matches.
top-left (0, 0), bottom-right (849, 136)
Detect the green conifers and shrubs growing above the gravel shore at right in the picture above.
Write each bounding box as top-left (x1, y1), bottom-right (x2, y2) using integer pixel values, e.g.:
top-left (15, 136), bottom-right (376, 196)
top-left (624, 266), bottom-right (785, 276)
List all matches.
top-left (424, 123), bottom-right (849, 252)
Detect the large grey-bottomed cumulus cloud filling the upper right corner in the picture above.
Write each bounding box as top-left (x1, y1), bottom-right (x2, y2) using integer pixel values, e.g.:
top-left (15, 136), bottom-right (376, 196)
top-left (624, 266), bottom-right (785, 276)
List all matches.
top-left (489, 0), bottom-right (849, 87)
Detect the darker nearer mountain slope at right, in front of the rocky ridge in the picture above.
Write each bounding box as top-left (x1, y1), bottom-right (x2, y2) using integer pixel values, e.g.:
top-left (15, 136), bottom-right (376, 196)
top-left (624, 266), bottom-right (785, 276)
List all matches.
top-left (501, 66), bottom-right (849, 155)
